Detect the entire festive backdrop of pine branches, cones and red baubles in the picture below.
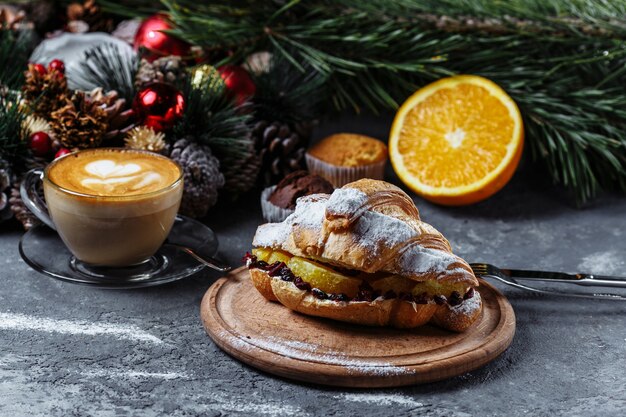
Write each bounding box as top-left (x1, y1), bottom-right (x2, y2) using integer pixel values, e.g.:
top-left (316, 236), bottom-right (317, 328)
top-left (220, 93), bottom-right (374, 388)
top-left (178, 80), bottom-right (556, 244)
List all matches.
top-left (0, 0), bottom-right (626, 226)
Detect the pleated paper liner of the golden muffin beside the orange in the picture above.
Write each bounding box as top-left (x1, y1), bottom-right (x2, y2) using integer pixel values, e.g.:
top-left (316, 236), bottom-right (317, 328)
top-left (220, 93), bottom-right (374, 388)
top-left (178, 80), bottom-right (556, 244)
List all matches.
top-left (305, 153), bottom-right (387, 188)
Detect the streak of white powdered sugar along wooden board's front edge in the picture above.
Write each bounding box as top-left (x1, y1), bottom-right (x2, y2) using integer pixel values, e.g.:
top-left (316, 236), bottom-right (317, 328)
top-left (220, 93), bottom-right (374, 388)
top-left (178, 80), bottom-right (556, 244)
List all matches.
top-left (220, 331), bottom-right (415, 376)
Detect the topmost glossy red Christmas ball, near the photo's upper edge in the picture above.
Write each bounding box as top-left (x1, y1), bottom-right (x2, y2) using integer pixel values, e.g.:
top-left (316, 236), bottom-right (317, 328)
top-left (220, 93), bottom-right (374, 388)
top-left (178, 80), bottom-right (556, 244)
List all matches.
top-left (133, 13), bottom-right (191, 62)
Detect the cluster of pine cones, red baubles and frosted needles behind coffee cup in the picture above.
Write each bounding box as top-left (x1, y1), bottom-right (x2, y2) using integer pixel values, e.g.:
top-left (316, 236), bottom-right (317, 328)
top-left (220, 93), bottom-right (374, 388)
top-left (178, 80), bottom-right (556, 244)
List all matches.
top-left (0, 2), bottom-right (314, 228)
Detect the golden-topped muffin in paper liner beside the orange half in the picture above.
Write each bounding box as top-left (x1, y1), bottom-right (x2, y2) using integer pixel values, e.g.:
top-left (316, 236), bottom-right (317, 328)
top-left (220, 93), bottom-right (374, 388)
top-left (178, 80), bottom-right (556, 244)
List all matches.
top-left (306, 133), bottom-right (388, 187)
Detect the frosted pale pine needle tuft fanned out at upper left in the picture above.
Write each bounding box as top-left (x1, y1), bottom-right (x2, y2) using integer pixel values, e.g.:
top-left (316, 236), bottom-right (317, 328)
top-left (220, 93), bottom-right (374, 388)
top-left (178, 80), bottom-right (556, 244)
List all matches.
top-left (67, 43), bottom-right (139, 103)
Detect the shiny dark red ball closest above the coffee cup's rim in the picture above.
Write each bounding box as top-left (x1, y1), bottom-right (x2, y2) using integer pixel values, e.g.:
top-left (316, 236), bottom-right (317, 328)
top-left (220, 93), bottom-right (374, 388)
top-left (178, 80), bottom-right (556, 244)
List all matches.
top-left (133, 83), bottom-right (185, 132)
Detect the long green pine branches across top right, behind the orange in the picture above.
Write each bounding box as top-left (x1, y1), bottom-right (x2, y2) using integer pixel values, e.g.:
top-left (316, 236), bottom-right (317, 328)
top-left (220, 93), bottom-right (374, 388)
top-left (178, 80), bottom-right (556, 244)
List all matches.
top-left (163, 0), bottom-right (626, 201)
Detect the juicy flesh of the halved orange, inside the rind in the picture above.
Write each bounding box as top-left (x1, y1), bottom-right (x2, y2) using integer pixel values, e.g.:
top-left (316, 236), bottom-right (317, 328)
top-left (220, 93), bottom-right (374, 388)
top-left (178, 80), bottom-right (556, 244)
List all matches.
top-left (398, 84), bottom-right (514, 187)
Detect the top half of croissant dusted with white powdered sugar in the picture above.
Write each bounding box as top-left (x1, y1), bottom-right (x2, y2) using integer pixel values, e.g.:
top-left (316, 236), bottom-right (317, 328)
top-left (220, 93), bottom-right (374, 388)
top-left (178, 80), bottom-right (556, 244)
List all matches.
top-left (253, 179), bottom-right (478, 286)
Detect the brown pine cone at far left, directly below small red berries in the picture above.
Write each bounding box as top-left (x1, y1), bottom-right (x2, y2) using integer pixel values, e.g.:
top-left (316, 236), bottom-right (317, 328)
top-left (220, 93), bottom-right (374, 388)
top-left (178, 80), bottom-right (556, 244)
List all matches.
top-left (22, 64), bottom-right (70, 119)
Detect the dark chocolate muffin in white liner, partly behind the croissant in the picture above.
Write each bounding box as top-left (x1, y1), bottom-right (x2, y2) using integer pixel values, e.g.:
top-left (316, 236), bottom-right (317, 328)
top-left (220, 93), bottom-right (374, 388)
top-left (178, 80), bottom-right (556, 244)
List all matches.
top-left (261, 171), bottom-right (334, 223)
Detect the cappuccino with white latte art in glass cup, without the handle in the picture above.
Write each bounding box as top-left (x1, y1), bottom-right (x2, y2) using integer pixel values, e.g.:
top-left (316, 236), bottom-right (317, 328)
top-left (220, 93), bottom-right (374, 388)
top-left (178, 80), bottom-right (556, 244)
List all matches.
top-left (43, 149), bottom-right (183, 266)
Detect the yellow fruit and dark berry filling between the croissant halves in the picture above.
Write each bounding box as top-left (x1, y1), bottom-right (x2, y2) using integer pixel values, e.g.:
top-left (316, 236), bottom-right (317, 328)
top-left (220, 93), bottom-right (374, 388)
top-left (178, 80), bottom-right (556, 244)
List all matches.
top-left (246, 248), bottom-right (474, 306)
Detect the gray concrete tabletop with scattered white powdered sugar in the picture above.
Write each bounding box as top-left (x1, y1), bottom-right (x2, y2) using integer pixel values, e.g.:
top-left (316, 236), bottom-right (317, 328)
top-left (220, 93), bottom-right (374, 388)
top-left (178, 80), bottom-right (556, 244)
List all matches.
top-left (0, 114), bottom-right (626, 416)
